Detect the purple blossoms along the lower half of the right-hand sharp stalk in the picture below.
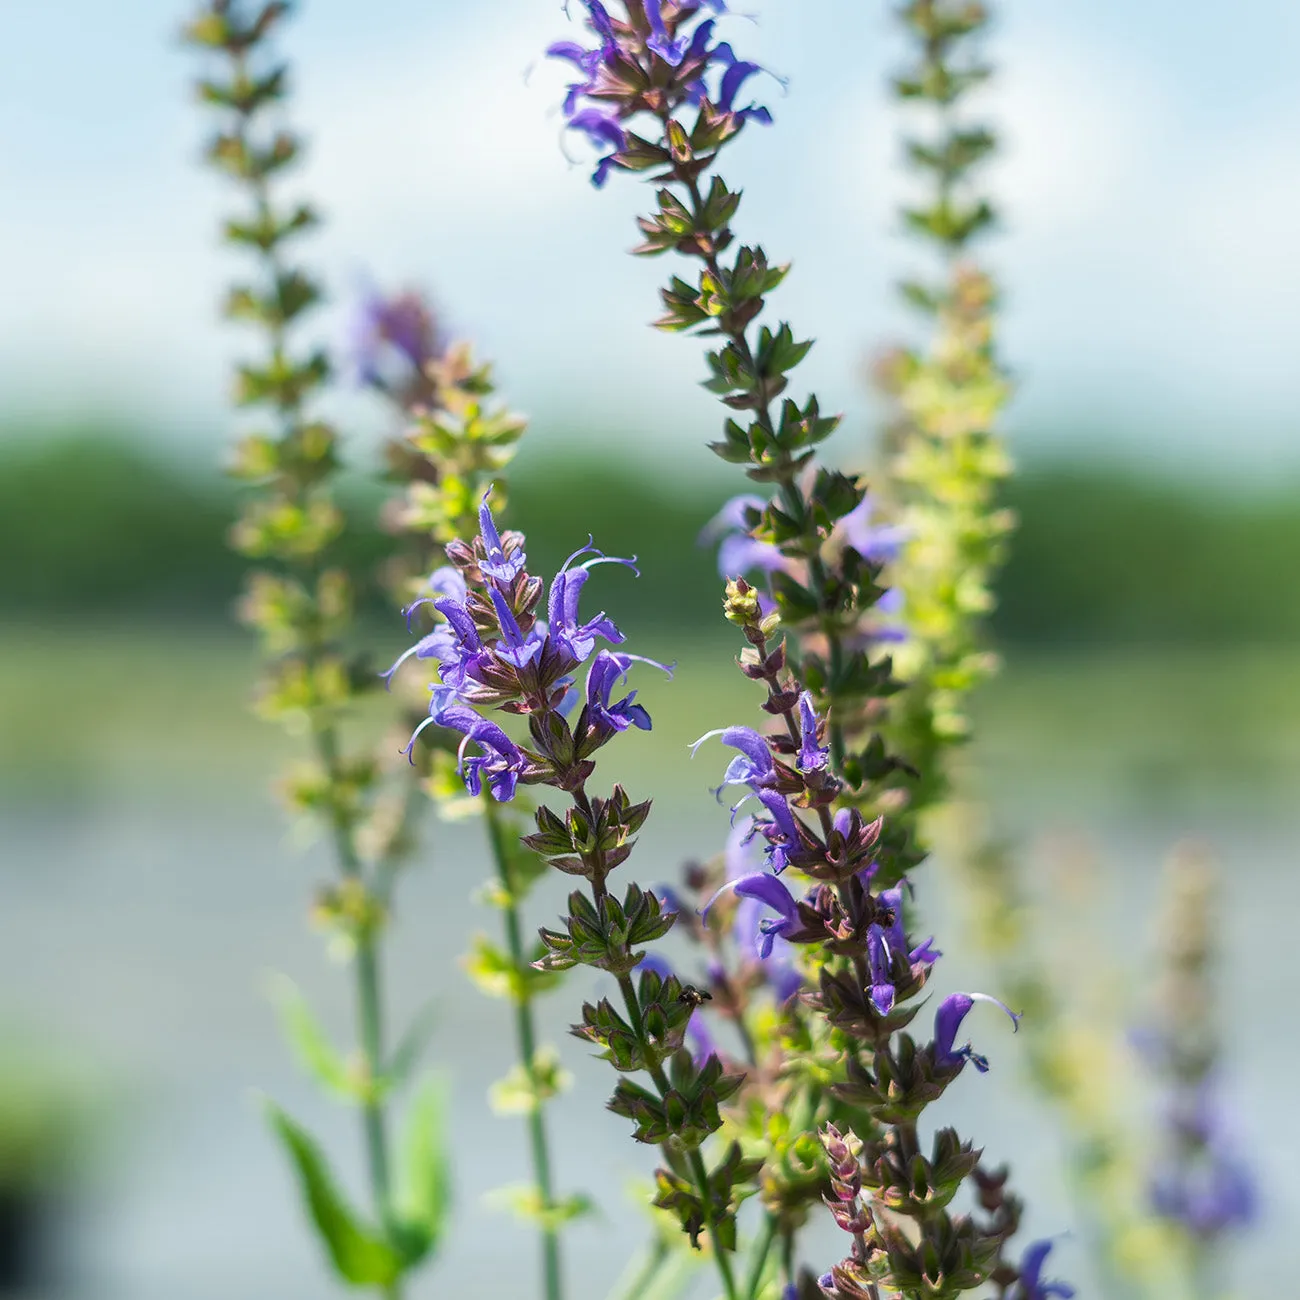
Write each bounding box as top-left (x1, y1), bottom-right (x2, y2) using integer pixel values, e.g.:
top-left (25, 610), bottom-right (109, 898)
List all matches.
top-left (692, 692), bottom-right (1019, 1073)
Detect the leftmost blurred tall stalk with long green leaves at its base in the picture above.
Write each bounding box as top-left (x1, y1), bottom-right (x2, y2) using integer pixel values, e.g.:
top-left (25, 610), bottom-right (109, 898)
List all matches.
top-left (186, 0), bottom-right (447, 1300)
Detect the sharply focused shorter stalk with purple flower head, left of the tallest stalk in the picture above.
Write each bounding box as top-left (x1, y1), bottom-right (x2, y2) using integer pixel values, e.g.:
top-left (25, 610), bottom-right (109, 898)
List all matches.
top-left (400, 497), bottom-right (754, 1300)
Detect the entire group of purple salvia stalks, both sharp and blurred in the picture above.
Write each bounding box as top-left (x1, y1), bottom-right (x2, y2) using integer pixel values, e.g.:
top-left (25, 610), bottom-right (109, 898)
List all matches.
top-left (172, 0), bottom-right (1249, 1300)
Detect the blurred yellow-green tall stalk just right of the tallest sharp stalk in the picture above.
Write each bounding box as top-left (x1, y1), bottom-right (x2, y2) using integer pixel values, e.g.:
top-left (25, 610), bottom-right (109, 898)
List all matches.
top-left (876, 0), bottom-right (1011, 818)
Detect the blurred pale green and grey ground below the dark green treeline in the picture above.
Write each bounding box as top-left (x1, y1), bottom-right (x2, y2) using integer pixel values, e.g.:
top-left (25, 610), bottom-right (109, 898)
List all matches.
top-left (0, 629), bottom-right (1300, 1300)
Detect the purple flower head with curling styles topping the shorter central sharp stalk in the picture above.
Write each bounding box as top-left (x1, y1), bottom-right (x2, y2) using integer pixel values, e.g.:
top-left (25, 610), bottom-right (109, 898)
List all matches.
top-left (385, 488), bottom-right (671, 801)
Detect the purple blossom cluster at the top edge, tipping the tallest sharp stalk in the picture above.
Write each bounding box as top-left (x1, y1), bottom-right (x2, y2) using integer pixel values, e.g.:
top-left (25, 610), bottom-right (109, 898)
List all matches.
top-left (546, 0), bottom-right (772, 186)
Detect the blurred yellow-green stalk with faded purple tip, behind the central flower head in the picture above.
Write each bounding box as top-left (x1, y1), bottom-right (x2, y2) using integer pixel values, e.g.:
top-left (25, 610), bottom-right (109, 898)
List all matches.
top-left (361, 290), bottom-right (574, 1300)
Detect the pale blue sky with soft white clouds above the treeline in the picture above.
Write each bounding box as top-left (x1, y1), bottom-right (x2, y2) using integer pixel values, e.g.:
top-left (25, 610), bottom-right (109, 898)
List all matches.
top-left (0, 0), bottom-right (1300, 469)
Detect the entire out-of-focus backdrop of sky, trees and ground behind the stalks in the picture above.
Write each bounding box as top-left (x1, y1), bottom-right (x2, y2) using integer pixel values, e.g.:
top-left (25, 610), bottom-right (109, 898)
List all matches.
top-left (0, 0), bottom-right (1300, 1300)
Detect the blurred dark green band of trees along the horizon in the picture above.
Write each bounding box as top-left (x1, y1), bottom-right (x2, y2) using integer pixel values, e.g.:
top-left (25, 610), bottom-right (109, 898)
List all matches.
top-left (0, 434), bottom-right (1300, 646)
